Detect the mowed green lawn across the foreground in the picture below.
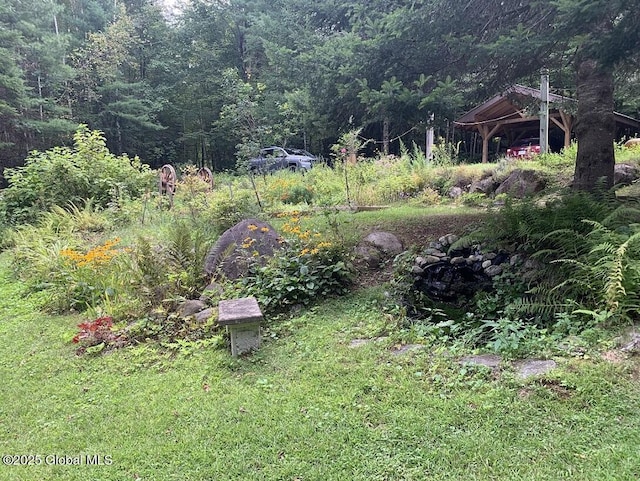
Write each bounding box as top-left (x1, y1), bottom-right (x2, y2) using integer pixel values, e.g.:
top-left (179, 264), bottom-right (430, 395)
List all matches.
top-left (0, 254), bottom-right (640, 481)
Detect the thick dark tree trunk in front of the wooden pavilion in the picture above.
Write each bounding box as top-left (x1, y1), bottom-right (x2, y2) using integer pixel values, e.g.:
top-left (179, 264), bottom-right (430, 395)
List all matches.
top-left (573, 58), bottom-right (616, 192)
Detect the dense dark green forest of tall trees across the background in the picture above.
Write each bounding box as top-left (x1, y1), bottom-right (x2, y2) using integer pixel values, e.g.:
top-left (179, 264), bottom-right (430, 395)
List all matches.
top-left (0, 0), bottom-right (640, 182)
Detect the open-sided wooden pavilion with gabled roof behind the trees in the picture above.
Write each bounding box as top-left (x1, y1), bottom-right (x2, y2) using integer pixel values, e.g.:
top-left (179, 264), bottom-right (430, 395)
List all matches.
top-left (455, 85), bottom-right (640, 162)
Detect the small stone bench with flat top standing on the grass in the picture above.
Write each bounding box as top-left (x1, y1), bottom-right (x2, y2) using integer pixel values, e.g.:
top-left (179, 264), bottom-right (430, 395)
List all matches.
top-left (218, 297), bottom-right (264, 357)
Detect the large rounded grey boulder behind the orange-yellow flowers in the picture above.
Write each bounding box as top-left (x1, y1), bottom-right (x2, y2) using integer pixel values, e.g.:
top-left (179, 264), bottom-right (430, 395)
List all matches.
top-left (204, 219), bottom-right (282, 279)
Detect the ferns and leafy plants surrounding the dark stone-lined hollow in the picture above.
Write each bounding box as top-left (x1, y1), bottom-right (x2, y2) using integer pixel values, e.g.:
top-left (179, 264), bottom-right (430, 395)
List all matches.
top-left (390, 193), bottom-right (640, 356)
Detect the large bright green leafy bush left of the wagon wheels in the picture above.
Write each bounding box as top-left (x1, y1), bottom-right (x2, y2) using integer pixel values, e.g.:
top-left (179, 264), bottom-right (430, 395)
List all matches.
top-left (0, 126), bottom-right (153, 224)
